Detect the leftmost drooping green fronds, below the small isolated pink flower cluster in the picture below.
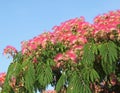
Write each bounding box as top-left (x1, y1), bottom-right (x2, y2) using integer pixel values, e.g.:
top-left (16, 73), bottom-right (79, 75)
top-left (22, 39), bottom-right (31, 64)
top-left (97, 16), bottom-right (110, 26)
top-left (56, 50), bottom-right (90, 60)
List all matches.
top-left (2, 52), bottom-right (22, 93)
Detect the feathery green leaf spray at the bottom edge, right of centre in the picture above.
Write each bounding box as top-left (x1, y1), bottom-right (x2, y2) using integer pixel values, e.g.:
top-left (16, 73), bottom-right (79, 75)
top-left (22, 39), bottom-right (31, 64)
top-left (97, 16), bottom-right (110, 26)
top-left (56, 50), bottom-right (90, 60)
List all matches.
top-left (67, 71), bottom-right (92, 93)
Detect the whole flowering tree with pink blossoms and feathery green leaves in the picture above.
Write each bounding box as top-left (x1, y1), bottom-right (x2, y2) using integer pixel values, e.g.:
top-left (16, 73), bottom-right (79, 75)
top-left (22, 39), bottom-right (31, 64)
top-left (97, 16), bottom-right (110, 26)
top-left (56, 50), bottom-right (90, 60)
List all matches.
top-left (0, 10), bottom-right (120, 93)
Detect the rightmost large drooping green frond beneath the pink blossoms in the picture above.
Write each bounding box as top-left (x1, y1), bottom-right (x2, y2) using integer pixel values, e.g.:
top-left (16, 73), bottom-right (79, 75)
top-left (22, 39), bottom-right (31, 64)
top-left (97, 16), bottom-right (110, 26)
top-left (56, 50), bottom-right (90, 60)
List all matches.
top-left (98, 41), bottom-right (118, 75)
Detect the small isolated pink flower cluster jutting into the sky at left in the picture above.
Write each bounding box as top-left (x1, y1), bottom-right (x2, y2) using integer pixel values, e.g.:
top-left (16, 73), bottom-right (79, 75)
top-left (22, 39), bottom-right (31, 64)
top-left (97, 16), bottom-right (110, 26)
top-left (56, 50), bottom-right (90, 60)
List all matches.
top-left (3, 46), bottom-right (17, 57)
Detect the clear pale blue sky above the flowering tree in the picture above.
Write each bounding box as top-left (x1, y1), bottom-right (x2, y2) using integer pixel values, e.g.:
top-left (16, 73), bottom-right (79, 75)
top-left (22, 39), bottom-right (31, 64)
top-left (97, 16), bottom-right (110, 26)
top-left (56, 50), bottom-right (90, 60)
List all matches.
top-left (0, 0), bottom-right (120, 72)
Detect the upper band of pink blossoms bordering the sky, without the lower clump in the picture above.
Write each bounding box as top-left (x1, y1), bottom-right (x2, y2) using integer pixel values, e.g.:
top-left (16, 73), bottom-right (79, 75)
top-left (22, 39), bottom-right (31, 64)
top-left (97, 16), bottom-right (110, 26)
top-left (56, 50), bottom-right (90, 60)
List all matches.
top-left (22, 10), bottom-right (120, 54)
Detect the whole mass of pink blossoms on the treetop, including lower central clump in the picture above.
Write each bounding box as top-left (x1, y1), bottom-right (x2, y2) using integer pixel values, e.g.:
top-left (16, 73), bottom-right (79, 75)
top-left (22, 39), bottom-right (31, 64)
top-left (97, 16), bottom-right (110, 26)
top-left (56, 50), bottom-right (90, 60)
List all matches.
top-left (22, 10), bottom-right (120, 67)
